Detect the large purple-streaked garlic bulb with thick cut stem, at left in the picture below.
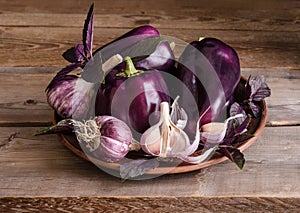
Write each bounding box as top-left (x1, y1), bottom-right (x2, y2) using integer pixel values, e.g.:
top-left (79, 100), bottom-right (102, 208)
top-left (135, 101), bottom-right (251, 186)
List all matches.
top-left (46, 54), bottom-right (122, 120)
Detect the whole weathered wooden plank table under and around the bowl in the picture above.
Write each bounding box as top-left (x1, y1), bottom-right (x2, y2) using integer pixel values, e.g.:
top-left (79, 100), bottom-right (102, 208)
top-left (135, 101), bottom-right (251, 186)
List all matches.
top-left (0, 0), bottom-right (300, 212)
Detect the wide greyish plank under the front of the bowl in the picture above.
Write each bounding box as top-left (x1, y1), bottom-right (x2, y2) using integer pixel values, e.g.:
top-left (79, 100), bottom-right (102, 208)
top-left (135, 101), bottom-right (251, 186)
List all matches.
top-left (0, 127), bottom-right (300, 199)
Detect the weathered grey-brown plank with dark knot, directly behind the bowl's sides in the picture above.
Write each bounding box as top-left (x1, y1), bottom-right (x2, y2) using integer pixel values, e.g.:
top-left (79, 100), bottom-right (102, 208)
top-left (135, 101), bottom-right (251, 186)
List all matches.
top-left (0, 67), bottom-right (300, 126)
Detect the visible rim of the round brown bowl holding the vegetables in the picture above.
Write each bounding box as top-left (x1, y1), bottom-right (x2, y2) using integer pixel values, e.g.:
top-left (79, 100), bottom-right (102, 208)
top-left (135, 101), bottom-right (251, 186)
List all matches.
top-left (54, 77), bottom-right (267, 175)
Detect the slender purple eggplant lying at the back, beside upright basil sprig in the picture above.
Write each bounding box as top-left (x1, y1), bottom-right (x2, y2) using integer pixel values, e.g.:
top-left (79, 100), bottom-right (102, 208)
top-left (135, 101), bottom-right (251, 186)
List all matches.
top-left (93, 25), bottom-right (159, 62)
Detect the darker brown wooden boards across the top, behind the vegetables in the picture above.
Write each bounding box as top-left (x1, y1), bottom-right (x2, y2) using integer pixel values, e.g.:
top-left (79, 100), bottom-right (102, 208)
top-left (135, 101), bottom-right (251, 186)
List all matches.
top-left (0, 1), bottom-right (300, 69)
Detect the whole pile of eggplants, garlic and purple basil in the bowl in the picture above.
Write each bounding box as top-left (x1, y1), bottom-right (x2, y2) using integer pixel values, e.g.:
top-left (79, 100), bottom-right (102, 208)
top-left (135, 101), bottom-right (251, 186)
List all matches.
top-left (36, 5), bottom-right (270, 179)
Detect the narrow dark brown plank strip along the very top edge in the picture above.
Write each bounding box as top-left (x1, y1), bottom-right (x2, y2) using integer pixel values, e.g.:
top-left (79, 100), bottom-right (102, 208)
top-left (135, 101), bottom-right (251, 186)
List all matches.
top-left (0, 0), bottom-right (300, 16)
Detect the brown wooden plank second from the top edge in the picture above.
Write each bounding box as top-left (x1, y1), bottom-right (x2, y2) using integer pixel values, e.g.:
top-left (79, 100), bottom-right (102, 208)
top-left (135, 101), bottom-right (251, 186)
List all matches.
top-left (0, 8), bottom-right (300, 32)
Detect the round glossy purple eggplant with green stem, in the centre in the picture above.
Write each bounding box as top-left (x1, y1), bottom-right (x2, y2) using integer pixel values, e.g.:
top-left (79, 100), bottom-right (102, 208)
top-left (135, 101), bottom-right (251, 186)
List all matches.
top-left (95, 57), bottom-right (170, 133)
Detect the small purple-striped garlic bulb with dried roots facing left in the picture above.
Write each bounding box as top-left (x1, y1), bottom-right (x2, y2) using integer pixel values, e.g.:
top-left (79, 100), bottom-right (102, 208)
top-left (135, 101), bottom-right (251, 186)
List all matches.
top-left (74, 116), bottom-right (132, 162)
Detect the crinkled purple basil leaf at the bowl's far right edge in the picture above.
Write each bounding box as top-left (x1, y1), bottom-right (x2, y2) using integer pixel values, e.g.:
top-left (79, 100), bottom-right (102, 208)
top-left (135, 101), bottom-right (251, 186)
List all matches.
top-left (249, 76), bottom-right (271, 101)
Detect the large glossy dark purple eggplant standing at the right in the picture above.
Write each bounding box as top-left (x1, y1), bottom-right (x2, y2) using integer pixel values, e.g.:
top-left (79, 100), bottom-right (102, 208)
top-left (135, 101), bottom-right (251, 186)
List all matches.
top-left (175, 38), bottom-right (240, 133)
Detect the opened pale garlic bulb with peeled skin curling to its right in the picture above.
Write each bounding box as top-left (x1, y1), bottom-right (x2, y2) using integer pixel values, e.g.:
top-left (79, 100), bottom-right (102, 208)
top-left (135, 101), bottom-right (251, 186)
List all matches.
top-left (140, 99), bottom-right (218, 164)
